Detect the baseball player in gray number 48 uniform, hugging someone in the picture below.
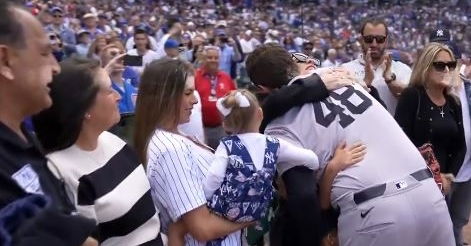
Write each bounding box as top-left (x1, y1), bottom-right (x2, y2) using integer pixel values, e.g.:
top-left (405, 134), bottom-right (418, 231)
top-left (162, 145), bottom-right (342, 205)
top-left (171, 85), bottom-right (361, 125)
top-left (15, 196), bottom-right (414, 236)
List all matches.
top-left (251, 46), bottom-right (455, 246)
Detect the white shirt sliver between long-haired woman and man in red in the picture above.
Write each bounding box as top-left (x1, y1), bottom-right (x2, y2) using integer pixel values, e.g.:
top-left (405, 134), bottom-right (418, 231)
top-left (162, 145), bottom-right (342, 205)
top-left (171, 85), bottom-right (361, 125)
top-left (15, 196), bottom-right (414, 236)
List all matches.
top-left (178, 90), bottom-right (206, 143)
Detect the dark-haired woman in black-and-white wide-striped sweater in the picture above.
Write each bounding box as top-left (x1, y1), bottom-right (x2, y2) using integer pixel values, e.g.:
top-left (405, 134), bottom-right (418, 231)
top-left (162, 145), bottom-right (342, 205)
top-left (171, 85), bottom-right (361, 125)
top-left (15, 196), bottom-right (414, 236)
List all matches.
top-left (33, 57), bottom-right (163, 246)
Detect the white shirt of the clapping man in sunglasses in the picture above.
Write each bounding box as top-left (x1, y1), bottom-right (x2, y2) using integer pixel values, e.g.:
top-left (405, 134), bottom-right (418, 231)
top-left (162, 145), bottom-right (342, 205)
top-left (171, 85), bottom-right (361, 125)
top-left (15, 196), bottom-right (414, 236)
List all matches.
top-left (342, 55), bottom-right (412, 115)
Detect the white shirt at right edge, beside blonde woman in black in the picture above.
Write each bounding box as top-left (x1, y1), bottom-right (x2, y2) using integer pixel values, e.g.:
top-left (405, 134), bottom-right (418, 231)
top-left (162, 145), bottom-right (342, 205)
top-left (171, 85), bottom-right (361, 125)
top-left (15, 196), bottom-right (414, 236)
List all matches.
top-left (456, 85), bottom-right (471, 182)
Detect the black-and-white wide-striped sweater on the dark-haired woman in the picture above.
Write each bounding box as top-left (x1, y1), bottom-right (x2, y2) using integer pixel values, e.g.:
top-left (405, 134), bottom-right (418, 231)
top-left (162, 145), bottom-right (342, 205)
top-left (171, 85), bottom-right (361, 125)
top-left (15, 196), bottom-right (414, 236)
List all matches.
top-left (48, 132), bottom-right (163, 246)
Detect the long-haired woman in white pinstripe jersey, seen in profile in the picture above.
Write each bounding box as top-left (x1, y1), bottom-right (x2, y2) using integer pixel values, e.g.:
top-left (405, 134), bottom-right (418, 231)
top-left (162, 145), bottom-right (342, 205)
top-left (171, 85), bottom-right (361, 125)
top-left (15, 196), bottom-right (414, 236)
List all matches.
top-left (134, 58), bottom-right (248, 246)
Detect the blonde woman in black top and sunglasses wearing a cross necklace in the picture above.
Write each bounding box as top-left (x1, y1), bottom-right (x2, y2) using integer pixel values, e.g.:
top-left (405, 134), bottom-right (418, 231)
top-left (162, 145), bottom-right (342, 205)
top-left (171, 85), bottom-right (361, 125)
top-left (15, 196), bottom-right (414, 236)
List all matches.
top-left (395, 43), bottom-right (465, 194)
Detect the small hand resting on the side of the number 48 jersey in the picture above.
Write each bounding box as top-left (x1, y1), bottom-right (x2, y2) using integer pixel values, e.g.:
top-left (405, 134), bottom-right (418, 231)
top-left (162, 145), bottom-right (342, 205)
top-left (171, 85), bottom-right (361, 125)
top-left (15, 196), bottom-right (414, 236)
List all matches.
top-left (330, 142), bottom-right (366, 171)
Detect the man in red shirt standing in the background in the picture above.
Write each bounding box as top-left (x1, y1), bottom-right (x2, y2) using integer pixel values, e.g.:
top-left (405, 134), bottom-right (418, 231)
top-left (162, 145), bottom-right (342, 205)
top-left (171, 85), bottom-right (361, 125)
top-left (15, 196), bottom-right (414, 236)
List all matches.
top-left (195, 46), bottom-right (236, 148)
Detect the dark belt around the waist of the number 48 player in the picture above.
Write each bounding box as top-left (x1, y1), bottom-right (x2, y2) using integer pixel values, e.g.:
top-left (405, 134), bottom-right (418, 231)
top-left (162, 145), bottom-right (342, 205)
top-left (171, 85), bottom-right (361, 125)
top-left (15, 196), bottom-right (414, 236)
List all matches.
top-left (353, 168), bottom-right (432, 205)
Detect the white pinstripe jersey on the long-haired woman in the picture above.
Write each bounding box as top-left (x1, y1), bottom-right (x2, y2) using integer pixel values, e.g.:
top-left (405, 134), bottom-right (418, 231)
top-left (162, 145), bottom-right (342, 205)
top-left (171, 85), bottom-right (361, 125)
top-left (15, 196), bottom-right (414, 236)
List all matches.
top-left (147, 129), bottom-right (241, 246)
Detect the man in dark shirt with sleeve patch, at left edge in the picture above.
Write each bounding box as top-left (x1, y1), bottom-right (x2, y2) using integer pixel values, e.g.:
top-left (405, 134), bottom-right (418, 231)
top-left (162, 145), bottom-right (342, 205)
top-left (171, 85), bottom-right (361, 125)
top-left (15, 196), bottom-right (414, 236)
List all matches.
top-left (0, 1), bottom-right (94, 245)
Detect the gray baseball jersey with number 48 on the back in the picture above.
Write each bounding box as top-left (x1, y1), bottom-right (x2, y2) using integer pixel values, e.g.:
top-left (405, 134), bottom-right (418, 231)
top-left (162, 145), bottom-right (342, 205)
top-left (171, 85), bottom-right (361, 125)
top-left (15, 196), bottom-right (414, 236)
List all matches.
top-left (265, 84), bottom-right (432, 209)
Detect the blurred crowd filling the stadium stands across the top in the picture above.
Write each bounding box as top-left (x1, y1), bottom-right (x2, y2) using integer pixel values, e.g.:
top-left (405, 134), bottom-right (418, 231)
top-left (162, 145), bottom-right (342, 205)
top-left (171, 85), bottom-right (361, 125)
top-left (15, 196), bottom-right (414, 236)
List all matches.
top-left (26, 0), bottom-right (471, 86)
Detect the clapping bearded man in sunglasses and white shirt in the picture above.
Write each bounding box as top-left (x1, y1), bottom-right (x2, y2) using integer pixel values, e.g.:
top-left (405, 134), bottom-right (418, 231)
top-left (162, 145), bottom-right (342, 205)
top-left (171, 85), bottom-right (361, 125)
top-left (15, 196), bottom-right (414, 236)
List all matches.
top-left (342, 18), bottom-right (412, 115)
